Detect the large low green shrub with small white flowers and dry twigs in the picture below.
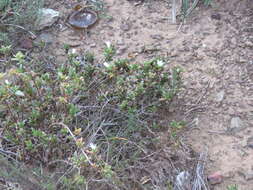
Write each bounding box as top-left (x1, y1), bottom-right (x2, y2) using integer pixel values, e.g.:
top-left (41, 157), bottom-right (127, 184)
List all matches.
top-left (0, 45), bottom-right (182, 189)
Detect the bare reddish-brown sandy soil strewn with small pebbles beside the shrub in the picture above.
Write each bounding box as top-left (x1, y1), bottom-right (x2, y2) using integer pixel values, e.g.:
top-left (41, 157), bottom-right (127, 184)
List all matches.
top-left (34, 0), bottom-right (253, 190)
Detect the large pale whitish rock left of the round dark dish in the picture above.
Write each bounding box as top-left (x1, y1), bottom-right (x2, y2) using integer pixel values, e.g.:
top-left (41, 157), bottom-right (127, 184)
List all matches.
top-left (37, 8), bottom-right (60, 30)
